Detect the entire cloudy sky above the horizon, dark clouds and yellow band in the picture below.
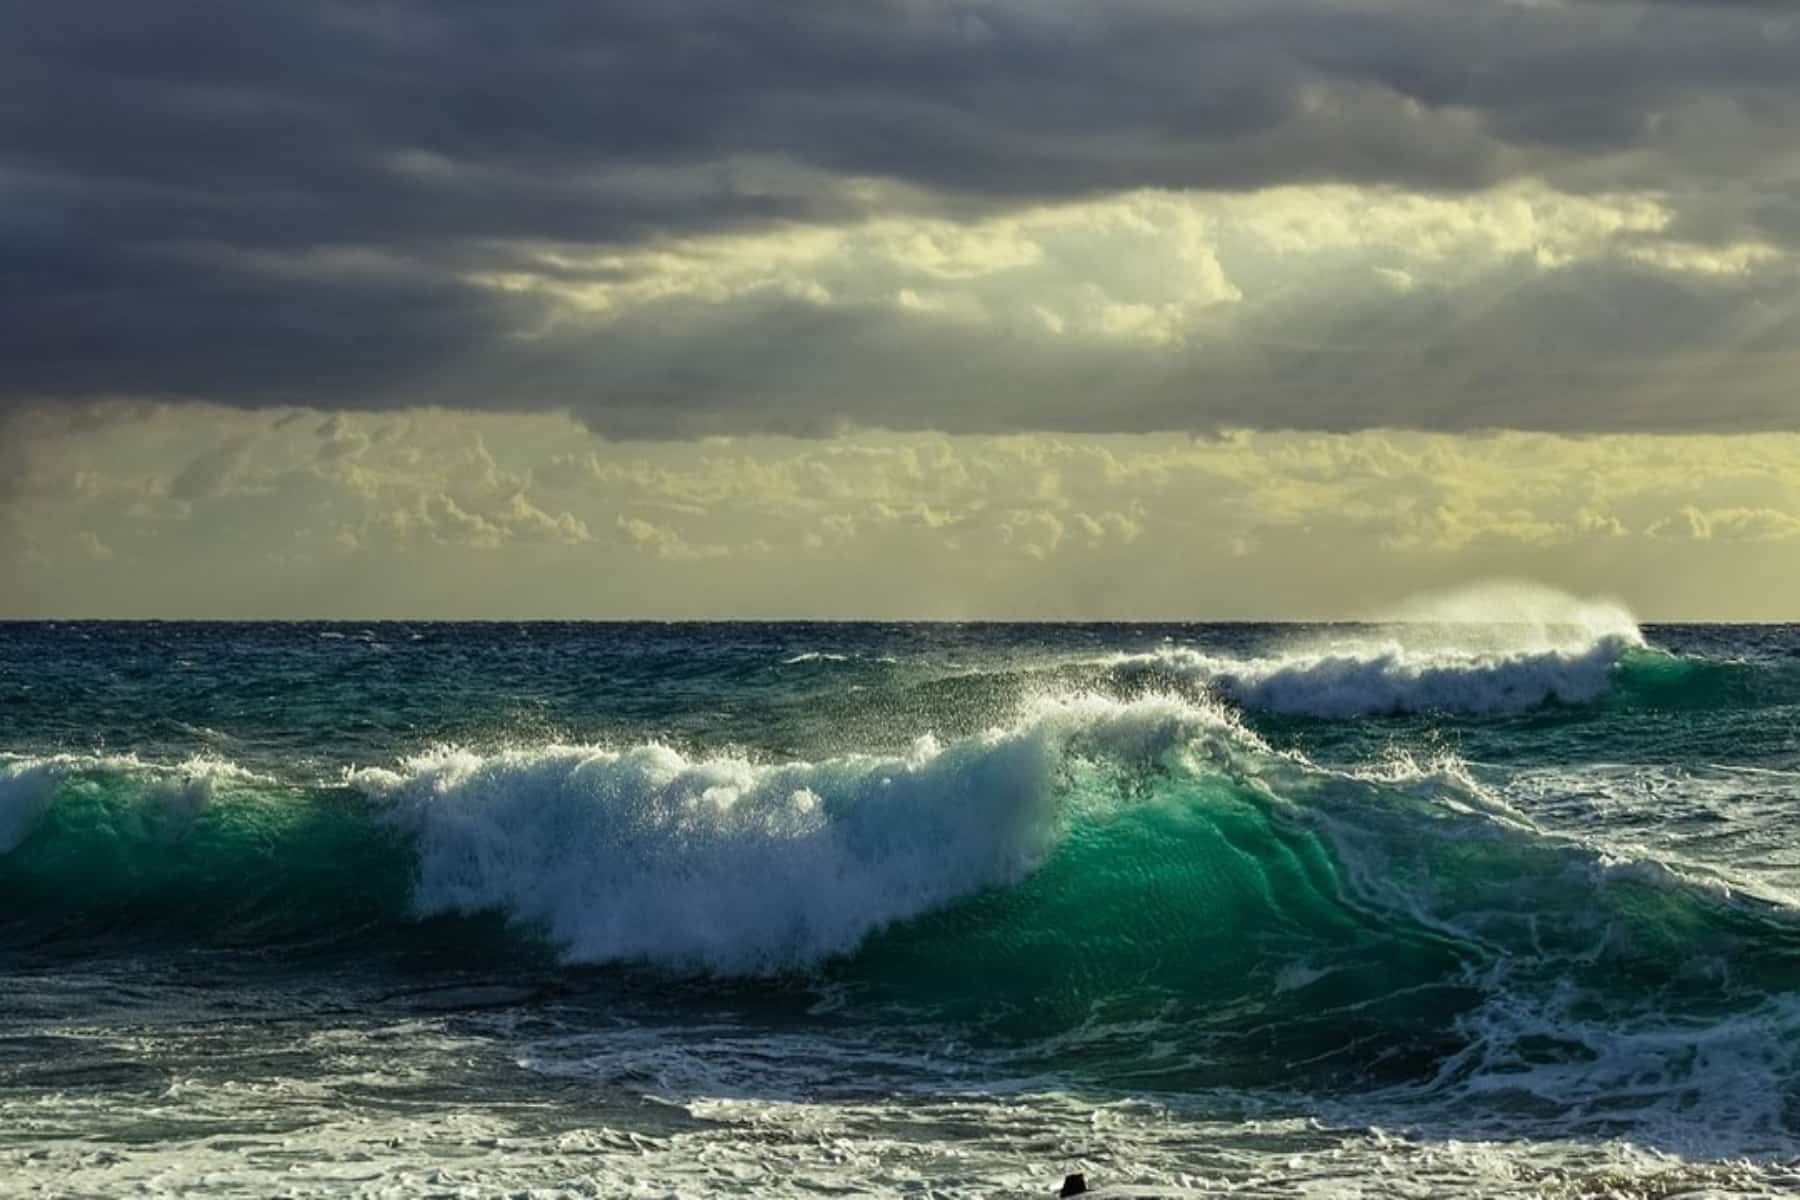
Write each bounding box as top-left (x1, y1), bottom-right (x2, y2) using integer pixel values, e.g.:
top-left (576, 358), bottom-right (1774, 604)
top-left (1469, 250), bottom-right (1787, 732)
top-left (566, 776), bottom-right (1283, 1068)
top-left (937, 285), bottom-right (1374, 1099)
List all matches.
top-left (0, 0), bottom-right (1800, 619)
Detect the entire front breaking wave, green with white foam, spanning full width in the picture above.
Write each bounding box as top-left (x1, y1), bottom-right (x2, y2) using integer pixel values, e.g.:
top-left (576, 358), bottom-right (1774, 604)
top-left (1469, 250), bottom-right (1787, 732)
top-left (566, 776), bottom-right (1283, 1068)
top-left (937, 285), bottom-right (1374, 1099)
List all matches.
top-left (0, 683), bottom-right (1800, 1133)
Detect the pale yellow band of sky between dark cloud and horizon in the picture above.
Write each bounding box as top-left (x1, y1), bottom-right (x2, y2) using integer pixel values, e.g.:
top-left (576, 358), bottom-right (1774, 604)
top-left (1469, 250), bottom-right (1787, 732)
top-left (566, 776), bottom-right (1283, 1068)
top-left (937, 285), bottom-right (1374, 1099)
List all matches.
top-left (14, 405), bottom-right (1800, 619)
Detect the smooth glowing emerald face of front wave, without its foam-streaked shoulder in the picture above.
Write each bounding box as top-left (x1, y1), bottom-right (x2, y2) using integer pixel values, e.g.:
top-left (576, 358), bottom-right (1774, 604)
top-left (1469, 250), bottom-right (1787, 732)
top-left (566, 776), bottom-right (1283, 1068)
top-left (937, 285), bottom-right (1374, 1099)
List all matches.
top-left (839, 759), bottom-right (1485, 1087)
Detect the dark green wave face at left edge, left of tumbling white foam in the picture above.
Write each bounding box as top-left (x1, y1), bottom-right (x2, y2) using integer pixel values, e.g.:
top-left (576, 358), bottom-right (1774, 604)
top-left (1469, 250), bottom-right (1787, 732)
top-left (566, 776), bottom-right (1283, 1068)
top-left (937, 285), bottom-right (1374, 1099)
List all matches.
top-left (0, 757), bottom-right (525, 964)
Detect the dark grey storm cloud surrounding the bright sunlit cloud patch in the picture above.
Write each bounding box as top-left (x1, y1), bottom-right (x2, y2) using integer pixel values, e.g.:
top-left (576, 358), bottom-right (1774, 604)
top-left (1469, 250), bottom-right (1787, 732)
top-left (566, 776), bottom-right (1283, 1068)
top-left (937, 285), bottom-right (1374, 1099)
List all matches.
top-left (0, 0), bottom-right (1800, 434)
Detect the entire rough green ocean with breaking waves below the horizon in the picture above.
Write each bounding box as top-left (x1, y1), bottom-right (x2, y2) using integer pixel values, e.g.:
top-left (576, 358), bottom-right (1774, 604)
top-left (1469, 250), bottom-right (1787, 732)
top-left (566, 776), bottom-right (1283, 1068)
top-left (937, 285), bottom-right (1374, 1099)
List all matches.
top-left (0, 596), bottom-right (1800, 1196)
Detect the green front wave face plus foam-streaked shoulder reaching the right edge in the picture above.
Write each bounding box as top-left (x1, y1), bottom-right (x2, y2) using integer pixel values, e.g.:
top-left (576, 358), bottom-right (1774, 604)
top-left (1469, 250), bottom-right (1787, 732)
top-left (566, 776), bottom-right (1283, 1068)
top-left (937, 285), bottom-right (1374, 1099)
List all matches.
top-left (833, 759), bottom-right (1800, 1092)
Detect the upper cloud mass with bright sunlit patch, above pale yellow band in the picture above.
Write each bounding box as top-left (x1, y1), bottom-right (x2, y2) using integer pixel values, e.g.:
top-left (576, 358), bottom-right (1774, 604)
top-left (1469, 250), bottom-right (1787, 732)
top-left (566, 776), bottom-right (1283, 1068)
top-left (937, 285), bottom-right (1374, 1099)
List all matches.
top-left (10, 0), bottom-right (1800, 431)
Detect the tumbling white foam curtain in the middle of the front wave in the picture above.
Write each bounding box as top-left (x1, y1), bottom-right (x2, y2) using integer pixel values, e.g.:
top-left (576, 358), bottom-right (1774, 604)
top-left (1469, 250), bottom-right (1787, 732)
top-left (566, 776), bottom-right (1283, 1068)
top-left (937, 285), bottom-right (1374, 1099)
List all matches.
top-left (351, 696), bottom-right (1242, 973)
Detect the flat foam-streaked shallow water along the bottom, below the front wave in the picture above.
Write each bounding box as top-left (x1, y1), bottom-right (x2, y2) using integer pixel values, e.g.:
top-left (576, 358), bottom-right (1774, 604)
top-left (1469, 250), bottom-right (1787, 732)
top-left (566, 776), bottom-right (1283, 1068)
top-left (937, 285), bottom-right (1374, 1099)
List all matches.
top-left (10, 1011), bottom-right (1800, 1200)
